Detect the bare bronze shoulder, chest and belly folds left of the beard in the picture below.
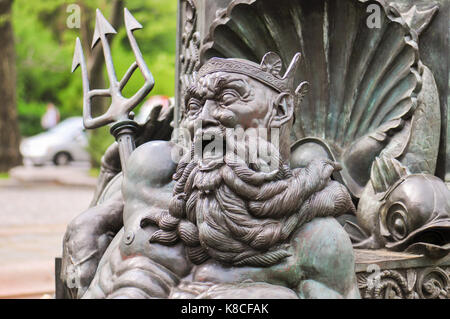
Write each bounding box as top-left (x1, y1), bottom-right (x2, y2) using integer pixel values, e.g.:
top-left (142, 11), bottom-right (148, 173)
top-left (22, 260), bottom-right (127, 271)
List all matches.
top-left (87, 141), bottom-right (192, 298)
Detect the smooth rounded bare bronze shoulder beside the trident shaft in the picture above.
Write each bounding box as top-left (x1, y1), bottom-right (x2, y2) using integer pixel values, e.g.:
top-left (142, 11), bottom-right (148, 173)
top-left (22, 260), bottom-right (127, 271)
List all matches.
top-left (126, 141), bottom-right (177, 187)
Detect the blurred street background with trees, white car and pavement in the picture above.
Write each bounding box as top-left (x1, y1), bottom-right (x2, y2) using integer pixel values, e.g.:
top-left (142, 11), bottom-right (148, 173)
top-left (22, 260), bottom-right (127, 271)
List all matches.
top-left (0, 0), bottom-right (177, 298)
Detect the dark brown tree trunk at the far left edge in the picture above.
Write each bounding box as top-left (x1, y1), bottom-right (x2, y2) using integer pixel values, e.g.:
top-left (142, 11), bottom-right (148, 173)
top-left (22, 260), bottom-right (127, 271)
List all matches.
top-left (0, 0), bottom-right (22, 172)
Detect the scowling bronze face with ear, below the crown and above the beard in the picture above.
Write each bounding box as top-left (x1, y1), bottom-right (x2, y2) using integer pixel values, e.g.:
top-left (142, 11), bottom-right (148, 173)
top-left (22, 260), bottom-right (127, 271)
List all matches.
top-left (179, 72), bottom-right (293, 163)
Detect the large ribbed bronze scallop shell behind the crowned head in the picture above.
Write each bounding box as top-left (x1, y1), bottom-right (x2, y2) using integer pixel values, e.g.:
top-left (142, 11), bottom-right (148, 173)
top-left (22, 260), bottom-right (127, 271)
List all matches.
top-left (200, 0), bottom-right (440, 174)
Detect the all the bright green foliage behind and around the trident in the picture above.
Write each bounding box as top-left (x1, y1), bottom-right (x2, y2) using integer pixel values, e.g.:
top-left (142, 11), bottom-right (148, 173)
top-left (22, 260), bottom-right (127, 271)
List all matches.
top-left (13, 0), bottom-right (177, 168)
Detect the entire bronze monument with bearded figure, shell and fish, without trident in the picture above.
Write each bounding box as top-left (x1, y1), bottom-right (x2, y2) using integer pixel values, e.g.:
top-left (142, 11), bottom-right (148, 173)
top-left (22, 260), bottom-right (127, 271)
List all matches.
top-left (61, 0), bottom-right (450, 298)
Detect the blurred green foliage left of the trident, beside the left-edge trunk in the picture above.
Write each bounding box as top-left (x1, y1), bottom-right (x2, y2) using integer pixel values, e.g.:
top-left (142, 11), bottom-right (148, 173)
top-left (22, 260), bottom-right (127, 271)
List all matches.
top-left (13, 0), bottom-right (81, 120)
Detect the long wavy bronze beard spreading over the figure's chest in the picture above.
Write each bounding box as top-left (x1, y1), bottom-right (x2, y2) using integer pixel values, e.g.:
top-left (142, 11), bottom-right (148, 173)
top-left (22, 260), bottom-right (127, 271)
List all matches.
top-left (148, 130), bottom-right (355, 267)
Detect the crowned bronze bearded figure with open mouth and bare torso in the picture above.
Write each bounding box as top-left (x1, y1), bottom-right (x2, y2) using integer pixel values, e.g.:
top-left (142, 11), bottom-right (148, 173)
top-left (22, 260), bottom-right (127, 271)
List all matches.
top-left (62, 53), bottom-right (360, 298)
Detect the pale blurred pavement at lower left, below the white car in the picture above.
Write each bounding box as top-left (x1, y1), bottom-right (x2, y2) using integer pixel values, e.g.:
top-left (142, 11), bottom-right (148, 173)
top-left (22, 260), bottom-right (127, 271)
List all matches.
top-left (0, 168), bottom-right (93, 298)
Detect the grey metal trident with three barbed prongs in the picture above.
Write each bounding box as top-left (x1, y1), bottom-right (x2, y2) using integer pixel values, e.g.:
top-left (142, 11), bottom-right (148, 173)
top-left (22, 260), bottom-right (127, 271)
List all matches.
top-left (72, 8), bottom-right (155, 172)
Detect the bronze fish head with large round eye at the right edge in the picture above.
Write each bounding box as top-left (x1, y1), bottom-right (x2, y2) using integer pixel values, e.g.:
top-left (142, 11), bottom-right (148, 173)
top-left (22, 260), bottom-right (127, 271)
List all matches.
top-left (343, 156), bottom-right (450, 258)
